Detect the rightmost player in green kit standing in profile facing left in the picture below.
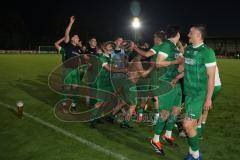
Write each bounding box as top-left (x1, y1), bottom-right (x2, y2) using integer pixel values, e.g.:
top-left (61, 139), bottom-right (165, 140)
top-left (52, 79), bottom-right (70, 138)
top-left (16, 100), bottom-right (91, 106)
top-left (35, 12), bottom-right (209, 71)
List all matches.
top-left (183, 25), bottom-right (216, 160)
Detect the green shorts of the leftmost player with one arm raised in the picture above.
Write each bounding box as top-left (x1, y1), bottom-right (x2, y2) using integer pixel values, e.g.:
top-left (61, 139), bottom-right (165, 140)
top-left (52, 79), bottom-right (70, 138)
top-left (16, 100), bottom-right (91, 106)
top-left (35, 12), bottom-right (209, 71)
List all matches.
top-left (63, 68), bottom-right (81, 85)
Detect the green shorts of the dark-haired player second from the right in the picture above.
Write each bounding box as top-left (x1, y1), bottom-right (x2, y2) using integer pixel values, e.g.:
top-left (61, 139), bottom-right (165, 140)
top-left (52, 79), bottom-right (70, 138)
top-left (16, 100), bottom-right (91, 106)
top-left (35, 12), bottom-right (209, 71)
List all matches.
top-left (158, 84), bottom-right (182, 111)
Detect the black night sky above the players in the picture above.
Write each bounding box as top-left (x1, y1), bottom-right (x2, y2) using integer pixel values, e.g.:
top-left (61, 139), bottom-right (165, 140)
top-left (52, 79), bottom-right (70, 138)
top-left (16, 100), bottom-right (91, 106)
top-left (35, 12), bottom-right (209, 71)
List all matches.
top-left (0, 0), bottom-right (240, 49)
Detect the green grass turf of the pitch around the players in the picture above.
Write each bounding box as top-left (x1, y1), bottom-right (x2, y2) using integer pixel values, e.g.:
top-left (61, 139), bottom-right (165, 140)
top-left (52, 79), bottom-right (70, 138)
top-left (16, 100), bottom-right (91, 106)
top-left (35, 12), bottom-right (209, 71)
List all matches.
top-left (0, 54), bottom-right (240, 160)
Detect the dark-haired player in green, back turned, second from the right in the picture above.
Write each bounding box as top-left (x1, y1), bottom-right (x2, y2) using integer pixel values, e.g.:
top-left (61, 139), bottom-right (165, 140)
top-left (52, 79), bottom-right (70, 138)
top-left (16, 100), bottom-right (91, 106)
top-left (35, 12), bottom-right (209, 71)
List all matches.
top-left (148, 26), bottom-right (182, 155)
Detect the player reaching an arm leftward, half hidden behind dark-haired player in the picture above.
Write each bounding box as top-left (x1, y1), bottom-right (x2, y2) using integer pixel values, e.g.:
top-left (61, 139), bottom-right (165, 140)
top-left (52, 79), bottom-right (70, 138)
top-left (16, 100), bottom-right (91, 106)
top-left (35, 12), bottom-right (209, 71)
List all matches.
top-left (135, 31), bottom-right (166, 124)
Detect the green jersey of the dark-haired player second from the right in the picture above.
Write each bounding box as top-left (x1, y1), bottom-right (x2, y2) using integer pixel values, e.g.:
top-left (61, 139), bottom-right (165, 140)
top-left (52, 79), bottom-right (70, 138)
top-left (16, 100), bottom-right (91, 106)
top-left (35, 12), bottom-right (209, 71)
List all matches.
top-left (151, 40), bottom-right (180, 82)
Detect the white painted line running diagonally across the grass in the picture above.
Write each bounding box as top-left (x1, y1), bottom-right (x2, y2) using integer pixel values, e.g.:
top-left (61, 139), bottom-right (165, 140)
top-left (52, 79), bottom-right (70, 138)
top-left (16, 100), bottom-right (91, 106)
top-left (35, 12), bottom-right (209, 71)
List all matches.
top-left (0, 101), bottom-right (129, 160)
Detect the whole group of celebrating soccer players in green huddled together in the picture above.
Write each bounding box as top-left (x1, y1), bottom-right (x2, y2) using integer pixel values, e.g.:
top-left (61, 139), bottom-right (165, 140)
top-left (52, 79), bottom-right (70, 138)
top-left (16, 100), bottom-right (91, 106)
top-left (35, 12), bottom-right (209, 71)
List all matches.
top-left (55, 16), bottom-right (221, 160)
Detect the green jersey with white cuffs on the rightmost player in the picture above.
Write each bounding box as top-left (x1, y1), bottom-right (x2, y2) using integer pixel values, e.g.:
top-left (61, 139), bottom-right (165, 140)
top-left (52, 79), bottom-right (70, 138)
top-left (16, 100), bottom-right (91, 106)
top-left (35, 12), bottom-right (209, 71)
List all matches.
top-left (184, 43), bottom-right (216, 96)
